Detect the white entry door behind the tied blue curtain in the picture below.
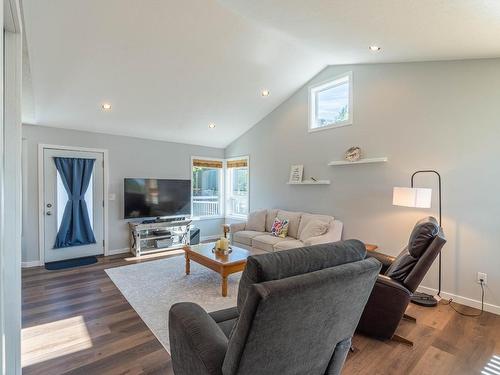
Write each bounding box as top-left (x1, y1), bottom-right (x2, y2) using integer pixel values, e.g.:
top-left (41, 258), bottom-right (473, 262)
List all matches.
top-left (43, 148), bottom-right (104, 263)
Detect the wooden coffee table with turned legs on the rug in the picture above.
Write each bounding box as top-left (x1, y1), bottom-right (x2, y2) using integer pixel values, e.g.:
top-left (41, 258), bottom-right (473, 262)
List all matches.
top-left (184, 243), bottom-right (250, 297)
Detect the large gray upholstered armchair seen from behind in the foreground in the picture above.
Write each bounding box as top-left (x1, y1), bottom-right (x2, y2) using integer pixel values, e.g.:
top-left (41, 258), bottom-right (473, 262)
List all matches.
top-left (169, 240), bottom-right (381, 375)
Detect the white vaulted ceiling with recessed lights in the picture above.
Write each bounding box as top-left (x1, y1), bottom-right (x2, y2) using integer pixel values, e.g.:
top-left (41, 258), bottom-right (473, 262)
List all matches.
top-left (23, 0), bottom-right (500, 147)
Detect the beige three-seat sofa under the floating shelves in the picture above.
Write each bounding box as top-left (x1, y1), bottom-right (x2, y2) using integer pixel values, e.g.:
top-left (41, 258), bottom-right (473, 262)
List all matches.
top-left (230, 209), bottom-right (343, 254)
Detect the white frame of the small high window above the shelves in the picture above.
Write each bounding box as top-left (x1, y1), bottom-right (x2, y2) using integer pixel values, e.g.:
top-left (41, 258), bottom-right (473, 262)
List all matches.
top-left (308, 71), bottom-right (353, 133)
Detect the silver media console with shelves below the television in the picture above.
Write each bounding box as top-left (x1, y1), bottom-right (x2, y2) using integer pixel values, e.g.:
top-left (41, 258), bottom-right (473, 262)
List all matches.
top-left (128, 219), bottom-right (192, 257)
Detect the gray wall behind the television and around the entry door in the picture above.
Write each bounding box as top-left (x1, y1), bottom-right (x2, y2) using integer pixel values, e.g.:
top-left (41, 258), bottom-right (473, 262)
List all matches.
top-left (22, 125), bottom-right (224, 262)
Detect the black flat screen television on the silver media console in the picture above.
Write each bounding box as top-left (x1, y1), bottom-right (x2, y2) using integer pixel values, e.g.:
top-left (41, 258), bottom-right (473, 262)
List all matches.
top-left (124, 178), bottom-right (191, 219)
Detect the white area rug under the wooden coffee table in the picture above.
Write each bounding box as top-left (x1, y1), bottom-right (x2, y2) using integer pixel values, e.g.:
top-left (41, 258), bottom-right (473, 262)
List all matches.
top-left (106, 256), bottom-right (241, 353)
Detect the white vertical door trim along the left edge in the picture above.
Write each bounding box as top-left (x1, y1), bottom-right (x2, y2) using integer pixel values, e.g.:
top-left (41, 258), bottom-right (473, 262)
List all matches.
top-left (0, 0), bottom-right (22, 375)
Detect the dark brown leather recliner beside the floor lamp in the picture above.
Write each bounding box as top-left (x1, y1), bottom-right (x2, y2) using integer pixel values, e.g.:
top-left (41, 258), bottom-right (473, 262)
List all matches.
top-left (357, 217), bottom-right (446, 344)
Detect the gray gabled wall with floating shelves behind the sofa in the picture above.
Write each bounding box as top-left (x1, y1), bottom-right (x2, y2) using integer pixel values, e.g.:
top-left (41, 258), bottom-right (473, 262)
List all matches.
top-left (226, 59), bottom-right (500, 311)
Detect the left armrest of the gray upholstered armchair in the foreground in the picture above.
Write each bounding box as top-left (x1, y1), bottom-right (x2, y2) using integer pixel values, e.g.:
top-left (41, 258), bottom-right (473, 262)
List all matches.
top-left (168, 302), bottom-right (228, 375)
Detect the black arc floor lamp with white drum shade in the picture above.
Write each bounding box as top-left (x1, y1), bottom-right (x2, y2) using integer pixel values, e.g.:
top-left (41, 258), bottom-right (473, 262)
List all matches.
top-left (392, 169), bottom-right (441, 307)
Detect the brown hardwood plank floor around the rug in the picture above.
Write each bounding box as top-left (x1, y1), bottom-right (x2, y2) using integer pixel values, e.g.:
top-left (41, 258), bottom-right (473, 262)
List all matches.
top-left (22, 256), bottom-right (500, 375)
